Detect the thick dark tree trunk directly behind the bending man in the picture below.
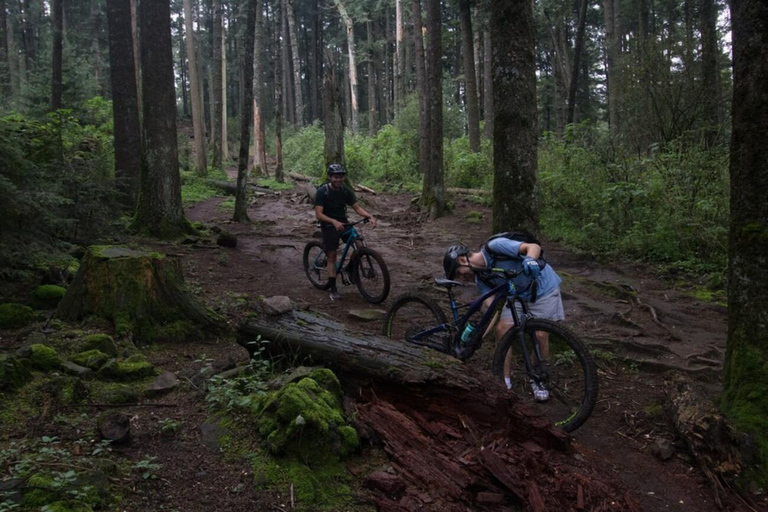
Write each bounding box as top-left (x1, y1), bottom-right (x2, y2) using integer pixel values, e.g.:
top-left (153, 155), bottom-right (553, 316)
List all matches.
top-left (490, 0), bottom-right (539, 232)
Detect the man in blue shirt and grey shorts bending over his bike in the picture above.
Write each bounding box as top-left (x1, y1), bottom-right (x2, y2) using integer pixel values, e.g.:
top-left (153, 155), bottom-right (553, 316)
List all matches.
top-left (443, 237), bottom-right (565, 402)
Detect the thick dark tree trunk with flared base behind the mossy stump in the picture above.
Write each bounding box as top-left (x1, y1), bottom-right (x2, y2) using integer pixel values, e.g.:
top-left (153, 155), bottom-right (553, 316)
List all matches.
top-left (133, 0), bottom-right (191, 238)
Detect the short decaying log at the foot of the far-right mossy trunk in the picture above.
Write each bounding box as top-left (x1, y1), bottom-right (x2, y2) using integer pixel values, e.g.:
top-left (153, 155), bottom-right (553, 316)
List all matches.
top-left (665, 374), bottom-right (742, 505)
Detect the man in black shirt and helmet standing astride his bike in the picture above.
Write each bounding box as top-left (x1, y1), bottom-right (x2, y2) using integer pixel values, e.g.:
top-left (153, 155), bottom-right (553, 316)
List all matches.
top-left (315, 164), bottom-right (376, 300)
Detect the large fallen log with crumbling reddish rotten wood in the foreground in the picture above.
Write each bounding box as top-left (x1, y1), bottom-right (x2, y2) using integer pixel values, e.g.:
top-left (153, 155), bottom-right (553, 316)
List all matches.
top-left (239, 311), bottom-right (639, 511)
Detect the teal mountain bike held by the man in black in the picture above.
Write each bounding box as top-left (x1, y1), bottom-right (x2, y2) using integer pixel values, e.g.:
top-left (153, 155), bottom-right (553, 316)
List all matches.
top-left (303, 219), bottom-right (390, 304)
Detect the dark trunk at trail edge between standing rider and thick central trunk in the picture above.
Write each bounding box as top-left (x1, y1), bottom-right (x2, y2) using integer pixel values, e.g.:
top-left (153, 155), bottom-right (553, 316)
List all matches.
top-left (421, 0), bottom-right (445, 219)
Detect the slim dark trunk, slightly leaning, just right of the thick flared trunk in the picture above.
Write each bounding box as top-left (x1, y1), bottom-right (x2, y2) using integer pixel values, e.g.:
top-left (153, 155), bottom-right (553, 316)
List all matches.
top-left (232, 0), bottom-right (261, 222)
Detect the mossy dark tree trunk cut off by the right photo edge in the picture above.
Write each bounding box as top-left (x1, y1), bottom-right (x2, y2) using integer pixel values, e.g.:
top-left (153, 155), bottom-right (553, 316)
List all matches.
top-left (722, 2), bottom-right (768, 482)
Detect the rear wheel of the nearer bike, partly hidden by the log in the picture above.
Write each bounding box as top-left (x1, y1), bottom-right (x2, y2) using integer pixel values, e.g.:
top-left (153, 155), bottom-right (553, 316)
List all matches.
top-left (382, 293), bottom-right (452, 354)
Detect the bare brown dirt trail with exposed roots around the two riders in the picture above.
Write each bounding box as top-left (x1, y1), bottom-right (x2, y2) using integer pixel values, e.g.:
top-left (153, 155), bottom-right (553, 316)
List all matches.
top-left (172, 181), bottom-right (748, 511)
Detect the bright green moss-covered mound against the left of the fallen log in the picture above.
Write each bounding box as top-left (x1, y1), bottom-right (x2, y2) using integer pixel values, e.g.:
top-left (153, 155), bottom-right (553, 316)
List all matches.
top-left (257, 369), bottom-right (358, 466)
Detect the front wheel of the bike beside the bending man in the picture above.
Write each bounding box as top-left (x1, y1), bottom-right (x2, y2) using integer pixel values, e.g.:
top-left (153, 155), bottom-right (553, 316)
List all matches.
top-left (493, 318), bottom-right (598, 432)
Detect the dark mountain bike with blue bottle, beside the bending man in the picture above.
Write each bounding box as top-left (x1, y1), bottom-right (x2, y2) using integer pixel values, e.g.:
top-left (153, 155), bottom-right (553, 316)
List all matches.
top-left (383, 268), bottom-right (598, 432)
